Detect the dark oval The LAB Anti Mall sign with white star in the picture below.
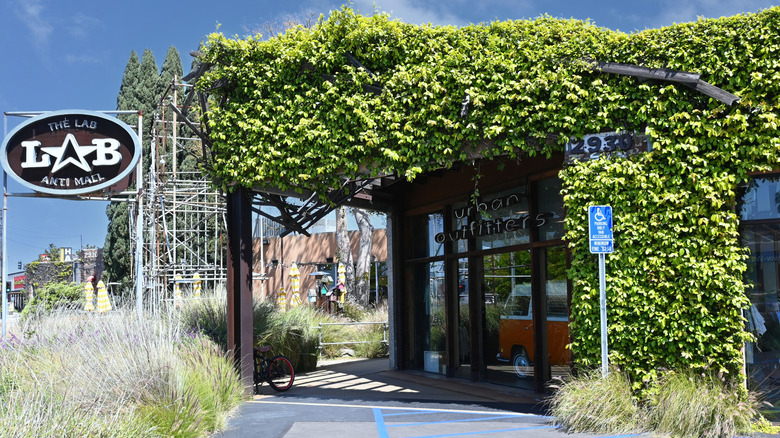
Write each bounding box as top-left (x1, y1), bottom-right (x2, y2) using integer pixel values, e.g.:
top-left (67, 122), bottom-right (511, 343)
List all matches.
top-left (0, 110), bottom-right (141, 195)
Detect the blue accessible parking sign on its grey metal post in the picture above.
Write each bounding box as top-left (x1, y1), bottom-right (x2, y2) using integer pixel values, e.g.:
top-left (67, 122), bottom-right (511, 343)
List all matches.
top-left (588, 205), bottom-right (614, 377)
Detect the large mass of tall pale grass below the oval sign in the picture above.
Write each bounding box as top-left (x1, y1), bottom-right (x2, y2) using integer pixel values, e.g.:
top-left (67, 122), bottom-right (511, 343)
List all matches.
top-left (0, 308), bottom-right (245, 437)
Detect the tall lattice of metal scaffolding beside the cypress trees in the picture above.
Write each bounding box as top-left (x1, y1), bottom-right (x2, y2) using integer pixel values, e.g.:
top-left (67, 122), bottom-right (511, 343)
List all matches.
top-left (139, 79), bottom-right (227, 307)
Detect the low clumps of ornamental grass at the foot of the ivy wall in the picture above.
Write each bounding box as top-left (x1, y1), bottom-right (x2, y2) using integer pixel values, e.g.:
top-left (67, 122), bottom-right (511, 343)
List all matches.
top-left (548, 370), bottom-right (766, 438)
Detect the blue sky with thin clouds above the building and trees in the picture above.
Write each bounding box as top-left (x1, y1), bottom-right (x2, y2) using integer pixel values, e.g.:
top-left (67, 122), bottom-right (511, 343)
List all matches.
top-left (0, 0), bottom-right (776, 272)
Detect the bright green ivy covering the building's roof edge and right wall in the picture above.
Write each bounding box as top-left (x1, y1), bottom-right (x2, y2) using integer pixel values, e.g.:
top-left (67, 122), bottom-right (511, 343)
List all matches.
top-left (198, 8), bottom-right (780, 389)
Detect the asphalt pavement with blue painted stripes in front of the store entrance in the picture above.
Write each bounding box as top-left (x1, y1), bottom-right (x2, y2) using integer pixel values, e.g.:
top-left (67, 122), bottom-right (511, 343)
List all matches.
top-left (216, 359), bottom-right (643, 438)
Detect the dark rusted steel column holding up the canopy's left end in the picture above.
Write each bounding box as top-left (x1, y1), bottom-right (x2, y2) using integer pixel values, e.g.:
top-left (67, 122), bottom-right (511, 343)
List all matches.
top-left (227, 188), bottom-right (254, 395)
